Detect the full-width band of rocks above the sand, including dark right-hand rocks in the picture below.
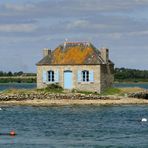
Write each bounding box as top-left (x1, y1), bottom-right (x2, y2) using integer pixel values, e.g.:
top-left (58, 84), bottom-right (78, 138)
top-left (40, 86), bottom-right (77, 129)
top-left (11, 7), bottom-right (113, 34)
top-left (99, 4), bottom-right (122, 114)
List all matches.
top-left (0, 90), bottom-right (148, 101)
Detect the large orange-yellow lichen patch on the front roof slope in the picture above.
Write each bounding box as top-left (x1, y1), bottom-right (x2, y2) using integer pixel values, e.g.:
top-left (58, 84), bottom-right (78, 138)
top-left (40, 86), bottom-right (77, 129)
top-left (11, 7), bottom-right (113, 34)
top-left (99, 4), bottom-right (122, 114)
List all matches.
top-left (53, 46), bottom-right (93, 64)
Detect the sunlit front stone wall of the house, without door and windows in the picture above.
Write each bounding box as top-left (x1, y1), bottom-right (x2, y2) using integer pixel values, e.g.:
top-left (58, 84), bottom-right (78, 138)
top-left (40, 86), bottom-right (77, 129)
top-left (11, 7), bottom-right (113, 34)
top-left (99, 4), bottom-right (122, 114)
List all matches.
top-left (37, 65), bottom-right (101, 93)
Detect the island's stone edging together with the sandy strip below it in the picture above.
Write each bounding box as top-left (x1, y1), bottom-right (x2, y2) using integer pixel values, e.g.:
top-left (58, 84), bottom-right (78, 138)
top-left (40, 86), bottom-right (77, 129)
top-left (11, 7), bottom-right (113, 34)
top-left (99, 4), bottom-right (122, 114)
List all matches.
top-left (0, 91), bottom-right (148, 106)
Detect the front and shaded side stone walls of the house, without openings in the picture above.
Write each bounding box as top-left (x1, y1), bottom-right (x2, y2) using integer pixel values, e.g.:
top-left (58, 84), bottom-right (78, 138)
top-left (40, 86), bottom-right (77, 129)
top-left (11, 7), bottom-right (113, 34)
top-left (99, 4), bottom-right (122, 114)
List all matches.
top-left (37, 64), bottom-right (114, 93)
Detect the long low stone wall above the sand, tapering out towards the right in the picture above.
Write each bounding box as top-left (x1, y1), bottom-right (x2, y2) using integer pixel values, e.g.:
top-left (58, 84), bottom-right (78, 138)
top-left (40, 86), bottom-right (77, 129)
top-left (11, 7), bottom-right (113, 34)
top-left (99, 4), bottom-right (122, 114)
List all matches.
top-left (0, 92), bottom-right (123, 101)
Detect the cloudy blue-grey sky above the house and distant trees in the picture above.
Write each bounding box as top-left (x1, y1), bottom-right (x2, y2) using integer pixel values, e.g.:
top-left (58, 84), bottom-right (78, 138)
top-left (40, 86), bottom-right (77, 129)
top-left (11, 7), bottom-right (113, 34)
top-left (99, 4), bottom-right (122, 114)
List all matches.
top-left (0, 0), bottom-right (148, 72)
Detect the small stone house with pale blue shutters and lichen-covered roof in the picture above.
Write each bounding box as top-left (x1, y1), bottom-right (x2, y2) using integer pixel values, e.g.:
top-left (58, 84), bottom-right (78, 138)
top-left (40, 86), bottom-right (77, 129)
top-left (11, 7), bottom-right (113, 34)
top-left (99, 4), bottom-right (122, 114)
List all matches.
top-left (37, 42), bottom-right (114, 93)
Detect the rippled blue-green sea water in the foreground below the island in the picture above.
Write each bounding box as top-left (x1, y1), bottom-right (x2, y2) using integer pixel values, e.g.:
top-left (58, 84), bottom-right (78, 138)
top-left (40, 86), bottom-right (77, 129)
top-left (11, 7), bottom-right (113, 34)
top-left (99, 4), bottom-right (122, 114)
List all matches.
top-left (0, 105), bottom-right (148, 148)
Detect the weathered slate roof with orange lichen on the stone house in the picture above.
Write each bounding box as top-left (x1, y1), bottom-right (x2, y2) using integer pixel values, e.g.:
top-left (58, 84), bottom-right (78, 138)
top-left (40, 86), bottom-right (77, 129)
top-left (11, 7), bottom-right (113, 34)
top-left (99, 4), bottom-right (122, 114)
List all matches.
top-left (37, 42), bottom-right (113, 65)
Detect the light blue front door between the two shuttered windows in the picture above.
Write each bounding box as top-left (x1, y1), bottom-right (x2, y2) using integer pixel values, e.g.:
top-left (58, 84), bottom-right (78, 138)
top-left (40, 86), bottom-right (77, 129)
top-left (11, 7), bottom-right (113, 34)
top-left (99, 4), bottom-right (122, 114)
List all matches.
top-left (64, 71), bottom-right (72, 89)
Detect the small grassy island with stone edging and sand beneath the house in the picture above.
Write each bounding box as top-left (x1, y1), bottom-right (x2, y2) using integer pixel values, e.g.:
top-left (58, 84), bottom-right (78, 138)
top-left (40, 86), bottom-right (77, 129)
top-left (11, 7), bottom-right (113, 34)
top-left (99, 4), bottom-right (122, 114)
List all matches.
top-left (0, 84), bottom-right (148, 106)
